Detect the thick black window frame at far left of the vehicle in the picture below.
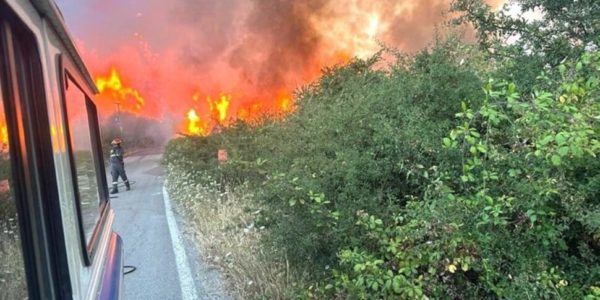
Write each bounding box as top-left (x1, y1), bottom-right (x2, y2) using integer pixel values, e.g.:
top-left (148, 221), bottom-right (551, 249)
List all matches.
top-left (0, 2), bottom-right (72, 299)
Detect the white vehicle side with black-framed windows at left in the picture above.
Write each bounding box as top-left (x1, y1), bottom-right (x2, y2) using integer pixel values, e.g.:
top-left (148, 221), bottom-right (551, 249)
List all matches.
top-left (0, 0), bottom-right (123, 299)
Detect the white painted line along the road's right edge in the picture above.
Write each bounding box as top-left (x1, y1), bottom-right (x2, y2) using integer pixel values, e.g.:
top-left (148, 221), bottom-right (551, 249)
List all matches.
top-left (163, 182), bottom-right (199, 300)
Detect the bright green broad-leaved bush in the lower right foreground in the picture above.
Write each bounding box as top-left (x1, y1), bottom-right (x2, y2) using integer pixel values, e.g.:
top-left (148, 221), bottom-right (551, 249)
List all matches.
top-left (324, 52), bottom-right (600, 299)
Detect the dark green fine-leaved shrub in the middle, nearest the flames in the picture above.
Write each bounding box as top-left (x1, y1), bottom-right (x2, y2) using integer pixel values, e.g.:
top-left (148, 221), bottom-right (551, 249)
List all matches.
top-left (166, 40), bottom-right (484, 277)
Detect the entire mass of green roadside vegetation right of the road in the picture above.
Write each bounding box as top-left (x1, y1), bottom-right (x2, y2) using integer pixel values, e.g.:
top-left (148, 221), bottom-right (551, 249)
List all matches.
top-left (165, 0), bottom-right (600, 299)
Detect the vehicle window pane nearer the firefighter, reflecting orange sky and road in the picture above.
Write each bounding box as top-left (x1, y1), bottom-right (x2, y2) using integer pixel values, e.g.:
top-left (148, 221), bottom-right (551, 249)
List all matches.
top-left (65, 78), bottom-right (101, 243)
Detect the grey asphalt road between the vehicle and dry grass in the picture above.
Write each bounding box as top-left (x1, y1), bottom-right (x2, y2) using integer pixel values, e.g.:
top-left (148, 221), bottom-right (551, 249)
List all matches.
top-left (108, 153), bottom-right (227, 300)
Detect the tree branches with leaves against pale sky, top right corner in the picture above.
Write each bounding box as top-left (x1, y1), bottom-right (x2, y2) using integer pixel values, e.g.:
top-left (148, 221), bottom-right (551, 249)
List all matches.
top-left (452, 0), bottom-right (600, 66)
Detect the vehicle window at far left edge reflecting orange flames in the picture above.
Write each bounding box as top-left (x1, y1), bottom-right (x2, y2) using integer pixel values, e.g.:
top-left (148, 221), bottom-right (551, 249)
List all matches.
top-left (0, 81), bottom-right (27, 299)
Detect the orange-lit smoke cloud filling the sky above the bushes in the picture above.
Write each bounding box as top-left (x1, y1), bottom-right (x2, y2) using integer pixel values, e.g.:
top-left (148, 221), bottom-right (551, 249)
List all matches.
top-left (58, 0), bottom-right (506, 132)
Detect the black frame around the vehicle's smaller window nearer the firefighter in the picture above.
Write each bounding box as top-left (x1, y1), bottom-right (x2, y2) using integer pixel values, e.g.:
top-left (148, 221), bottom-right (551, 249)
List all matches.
top-left (57, 54), bottom-right (110, 266)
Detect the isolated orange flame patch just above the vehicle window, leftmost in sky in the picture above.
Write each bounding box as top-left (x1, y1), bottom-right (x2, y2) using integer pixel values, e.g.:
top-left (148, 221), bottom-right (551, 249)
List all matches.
top-left (96, 67), bottom-right (145, 112)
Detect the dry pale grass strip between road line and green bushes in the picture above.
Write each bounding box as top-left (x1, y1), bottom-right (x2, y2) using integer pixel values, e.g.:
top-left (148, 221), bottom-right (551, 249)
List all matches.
top-left (167, 170), bottom-right (300, 299)
